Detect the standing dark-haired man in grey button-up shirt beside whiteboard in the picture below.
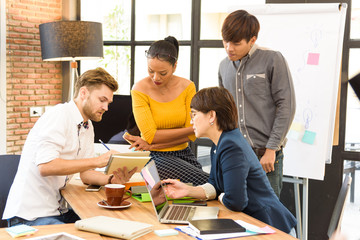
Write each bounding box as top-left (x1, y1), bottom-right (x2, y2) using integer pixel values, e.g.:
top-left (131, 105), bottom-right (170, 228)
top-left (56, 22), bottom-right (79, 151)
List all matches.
top-left (219, 10), bottom-right (295, 197)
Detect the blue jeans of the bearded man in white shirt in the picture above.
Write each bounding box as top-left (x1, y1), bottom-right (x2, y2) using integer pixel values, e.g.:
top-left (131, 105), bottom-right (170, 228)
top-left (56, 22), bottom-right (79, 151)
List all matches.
top-left (7, 209), bottom-right (80, 227)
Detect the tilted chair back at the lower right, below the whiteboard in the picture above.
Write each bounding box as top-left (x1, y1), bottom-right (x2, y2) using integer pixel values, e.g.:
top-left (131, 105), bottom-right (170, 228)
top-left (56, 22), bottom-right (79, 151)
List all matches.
top-left (328, 175), bottom-right (352, 237)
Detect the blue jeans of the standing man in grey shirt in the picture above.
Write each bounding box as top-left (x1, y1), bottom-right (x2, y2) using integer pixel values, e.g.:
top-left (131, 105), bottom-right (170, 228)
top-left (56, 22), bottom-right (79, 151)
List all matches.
top-left (253, 148), bottom-right (284, 198)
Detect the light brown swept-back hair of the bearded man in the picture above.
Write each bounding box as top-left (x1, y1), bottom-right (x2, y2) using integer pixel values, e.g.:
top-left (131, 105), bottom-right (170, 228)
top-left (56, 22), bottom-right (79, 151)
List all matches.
top-left (74, 67), bottom-right (119, 97)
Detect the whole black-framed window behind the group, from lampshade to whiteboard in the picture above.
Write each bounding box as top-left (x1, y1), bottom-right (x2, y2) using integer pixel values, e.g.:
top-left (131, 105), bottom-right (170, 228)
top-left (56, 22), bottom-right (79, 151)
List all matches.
top-left (80, 0), bottom-right (265, 95)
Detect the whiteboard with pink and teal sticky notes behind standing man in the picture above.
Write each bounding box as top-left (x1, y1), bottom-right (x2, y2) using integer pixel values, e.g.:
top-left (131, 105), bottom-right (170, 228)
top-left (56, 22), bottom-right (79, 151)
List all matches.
top-left (231, 3), bottom-right (347, 180)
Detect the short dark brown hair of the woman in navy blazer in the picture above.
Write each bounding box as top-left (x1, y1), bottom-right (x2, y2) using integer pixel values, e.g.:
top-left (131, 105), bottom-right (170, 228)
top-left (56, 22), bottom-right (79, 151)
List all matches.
top-left (190, 87), bottom-right (238, 131)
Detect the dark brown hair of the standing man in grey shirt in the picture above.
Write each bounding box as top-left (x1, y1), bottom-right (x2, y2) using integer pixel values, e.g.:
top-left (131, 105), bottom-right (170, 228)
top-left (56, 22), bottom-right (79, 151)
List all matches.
top-left (221, 10), bottom-right (260, 42)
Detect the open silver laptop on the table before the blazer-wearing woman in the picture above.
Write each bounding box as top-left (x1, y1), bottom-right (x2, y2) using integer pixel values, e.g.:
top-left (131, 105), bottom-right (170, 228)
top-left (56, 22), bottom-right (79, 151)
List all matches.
top-left (141, 160), bottom-right (219, 224)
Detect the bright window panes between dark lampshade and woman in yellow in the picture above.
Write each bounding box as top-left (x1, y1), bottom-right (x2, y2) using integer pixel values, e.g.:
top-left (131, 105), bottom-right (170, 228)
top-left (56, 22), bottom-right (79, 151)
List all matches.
top-left (80, 0), bottom-right (131, 95)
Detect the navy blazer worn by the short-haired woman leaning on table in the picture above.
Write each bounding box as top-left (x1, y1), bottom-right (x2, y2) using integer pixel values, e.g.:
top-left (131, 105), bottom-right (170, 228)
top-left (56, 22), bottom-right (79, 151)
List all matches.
top-left (209, 128), bottom-right (296, 233)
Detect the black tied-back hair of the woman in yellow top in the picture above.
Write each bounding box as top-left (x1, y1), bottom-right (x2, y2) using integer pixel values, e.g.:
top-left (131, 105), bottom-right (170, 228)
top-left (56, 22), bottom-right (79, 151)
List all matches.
top-left (145, 36), bottom-right (179, 66)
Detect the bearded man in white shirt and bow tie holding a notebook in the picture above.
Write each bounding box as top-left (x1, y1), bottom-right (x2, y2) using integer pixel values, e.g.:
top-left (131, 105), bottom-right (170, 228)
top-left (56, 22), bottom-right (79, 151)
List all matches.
top-left (3, 68), bottom-right (136, 227)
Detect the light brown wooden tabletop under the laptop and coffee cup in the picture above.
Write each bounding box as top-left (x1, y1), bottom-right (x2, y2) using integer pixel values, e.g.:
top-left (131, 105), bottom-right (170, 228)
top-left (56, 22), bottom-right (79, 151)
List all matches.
top-left (62, 178), bottom-right (296, 240)
